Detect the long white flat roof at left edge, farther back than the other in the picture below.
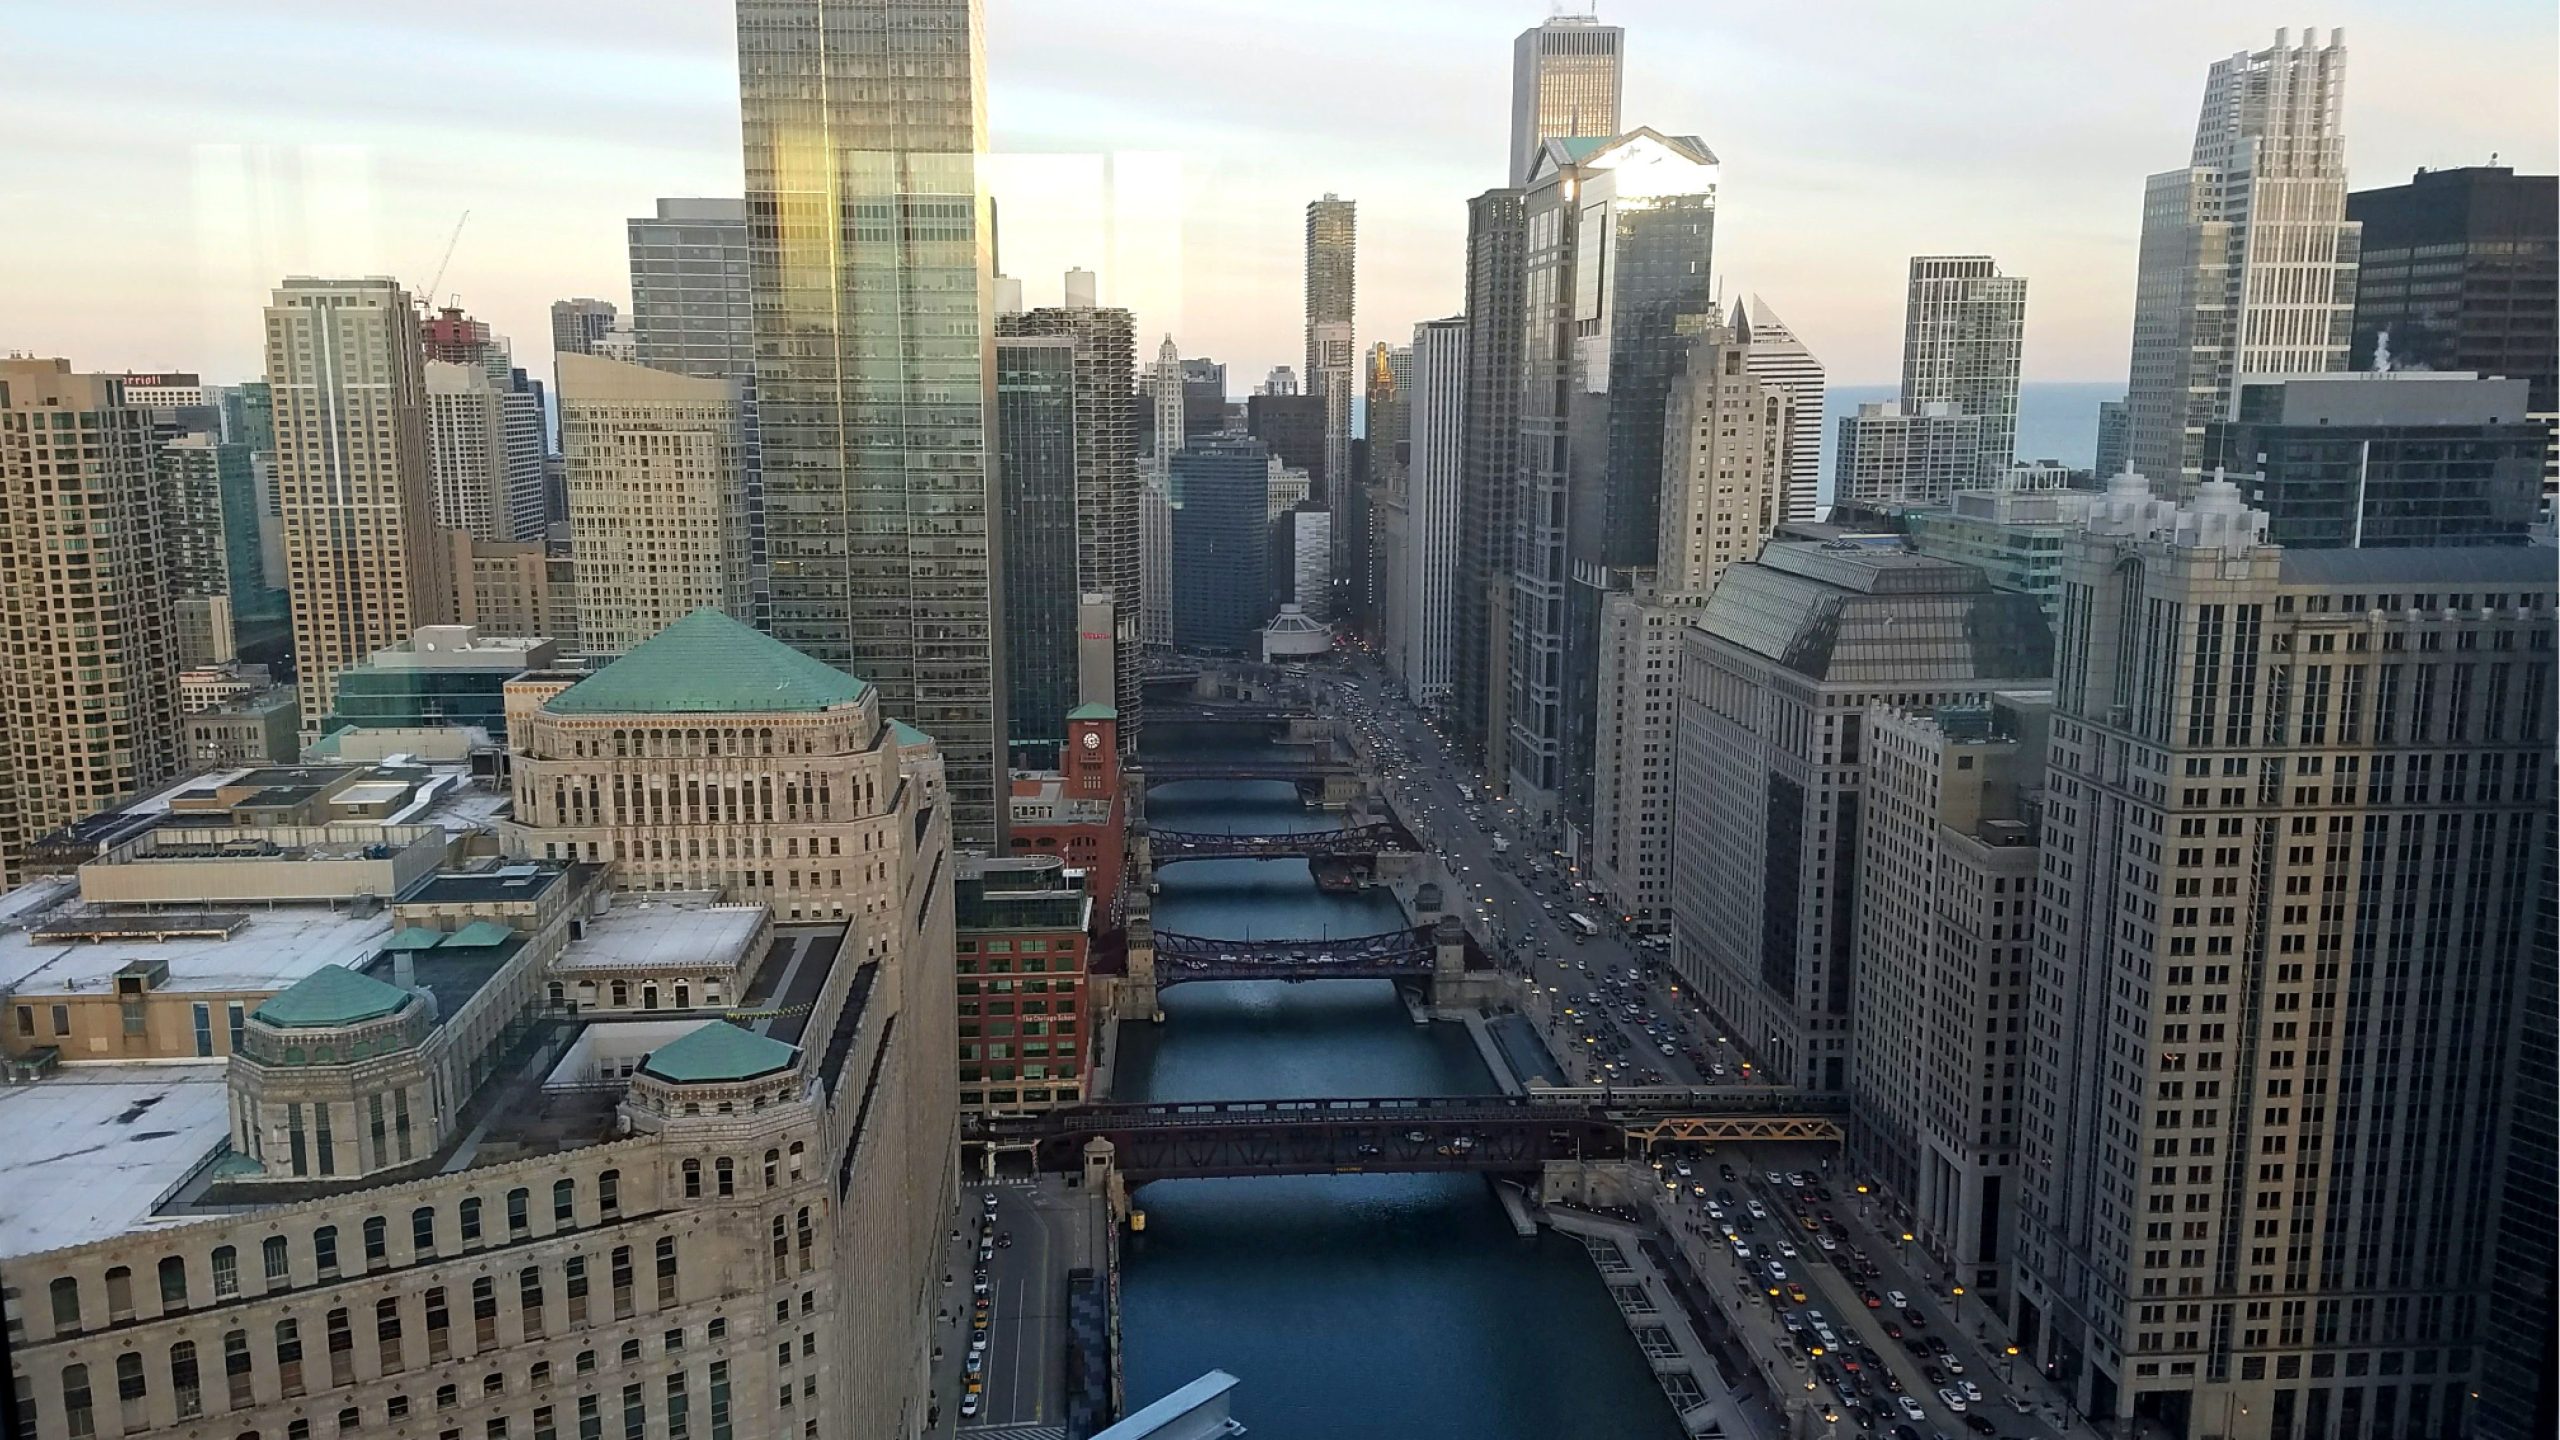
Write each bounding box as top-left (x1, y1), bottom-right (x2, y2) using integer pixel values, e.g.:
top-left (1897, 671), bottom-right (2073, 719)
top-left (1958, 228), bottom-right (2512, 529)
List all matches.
top-left (0, 904), bottom-right (392, 994)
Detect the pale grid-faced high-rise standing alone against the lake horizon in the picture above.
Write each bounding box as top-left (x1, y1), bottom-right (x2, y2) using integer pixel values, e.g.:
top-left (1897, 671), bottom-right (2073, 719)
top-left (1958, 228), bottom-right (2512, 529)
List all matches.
top-left (1902, 256), bottom-right (2028, 484)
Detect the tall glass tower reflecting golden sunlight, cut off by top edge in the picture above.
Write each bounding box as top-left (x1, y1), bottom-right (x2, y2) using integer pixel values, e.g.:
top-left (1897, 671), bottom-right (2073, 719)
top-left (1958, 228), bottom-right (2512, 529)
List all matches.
top-left (737, 0), bottom-right (1006, 846)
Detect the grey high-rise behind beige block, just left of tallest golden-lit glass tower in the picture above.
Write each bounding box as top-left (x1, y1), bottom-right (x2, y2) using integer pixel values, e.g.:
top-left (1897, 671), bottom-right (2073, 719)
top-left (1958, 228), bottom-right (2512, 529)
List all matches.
top-left (625, 197), bottom-right (755, 379)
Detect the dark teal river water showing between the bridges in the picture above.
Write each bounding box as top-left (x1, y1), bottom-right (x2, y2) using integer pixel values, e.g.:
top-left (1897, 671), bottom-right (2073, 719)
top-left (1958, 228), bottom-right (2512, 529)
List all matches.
top-left (1114, 733), bottom-right (1679, 1440)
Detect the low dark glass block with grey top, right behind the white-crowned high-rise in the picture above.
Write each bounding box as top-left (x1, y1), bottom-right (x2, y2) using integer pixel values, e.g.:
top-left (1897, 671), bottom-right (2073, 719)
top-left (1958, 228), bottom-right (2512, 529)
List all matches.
top-left (2204, 372), bottom-right (2550, 548)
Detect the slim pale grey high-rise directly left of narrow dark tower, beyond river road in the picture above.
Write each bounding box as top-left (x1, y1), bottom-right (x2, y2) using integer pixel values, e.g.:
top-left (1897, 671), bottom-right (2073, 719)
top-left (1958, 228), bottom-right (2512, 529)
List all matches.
top-left (1400, 315), bottom-right (1467, 710)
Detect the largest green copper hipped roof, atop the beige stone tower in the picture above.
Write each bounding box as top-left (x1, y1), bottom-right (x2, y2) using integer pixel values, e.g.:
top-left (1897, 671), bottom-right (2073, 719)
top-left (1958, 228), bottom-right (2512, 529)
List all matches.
top-left (548, 607), bottom-right (870, 715)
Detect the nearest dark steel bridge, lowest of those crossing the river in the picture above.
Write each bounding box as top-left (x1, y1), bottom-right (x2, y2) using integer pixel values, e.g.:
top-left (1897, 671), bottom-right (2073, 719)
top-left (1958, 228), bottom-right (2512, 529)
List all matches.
top-left (968, 1086), bottom-right (1841, 1184)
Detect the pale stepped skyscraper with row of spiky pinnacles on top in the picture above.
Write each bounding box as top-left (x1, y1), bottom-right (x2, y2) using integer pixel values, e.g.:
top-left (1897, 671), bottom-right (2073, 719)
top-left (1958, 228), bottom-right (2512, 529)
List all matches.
top-left (2125, 31), bottom-right (2358, 495)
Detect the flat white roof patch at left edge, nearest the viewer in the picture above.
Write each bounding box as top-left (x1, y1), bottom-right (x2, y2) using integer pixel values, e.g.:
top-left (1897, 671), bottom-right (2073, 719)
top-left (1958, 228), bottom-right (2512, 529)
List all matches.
top-left (0, 1063), bottom-right (230, 1261)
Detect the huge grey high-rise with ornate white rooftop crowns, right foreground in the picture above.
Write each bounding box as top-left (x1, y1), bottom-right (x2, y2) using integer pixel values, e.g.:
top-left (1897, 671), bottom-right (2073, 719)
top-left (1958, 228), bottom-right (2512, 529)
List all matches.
top-left (1999, 474), bottom-right (2555, 1435)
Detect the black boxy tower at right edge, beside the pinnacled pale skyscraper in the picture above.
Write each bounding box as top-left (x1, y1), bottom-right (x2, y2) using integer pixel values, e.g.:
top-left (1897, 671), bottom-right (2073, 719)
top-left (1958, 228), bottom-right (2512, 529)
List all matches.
top-left (2348, 164), bottom-right (2560, 415)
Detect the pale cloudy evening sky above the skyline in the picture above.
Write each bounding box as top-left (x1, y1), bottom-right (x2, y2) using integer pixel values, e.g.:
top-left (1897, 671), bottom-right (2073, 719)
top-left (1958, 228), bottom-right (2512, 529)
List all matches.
top-left (0, 0), bottom-right (2560, 395)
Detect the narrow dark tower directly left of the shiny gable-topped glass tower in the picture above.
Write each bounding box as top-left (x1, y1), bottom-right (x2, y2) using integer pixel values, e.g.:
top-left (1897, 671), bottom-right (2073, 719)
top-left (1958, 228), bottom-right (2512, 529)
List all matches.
top-left (1449, 190), bottom-right (1526, 787)
